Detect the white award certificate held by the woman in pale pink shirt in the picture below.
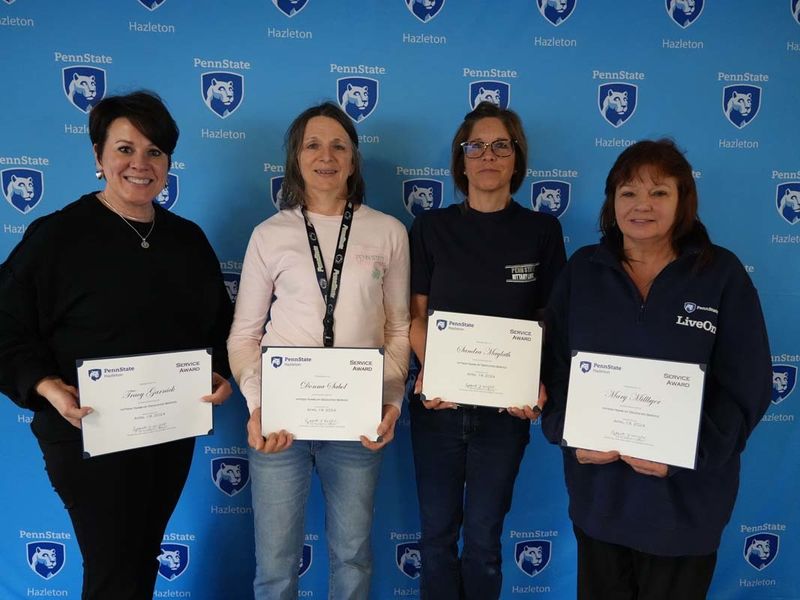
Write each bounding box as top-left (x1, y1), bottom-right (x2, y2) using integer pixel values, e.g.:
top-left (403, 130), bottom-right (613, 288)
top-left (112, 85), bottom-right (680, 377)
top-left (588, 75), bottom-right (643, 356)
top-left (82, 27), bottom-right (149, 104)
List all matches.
top-left (261, 346), bottom-right (383, 441)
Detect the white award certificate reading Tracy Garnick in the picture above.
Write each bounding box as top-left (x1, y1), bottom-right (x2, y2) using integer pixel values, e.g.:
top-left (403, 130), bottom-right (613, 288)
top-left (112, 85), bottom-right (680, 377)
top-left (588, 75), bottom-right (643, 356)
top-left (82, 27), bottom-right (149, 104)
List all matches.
top-left (77, 350), bottom-right (213, 458)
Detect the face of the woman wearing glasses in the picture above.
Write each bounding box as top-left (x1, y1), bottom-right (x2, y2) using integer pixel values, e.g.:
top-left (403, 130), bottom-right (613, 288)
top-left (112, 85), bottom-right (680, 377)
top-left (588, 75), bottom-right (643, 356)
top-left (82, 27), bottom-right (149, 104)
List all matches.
top-left (464, 117), bottom-right (514, 198)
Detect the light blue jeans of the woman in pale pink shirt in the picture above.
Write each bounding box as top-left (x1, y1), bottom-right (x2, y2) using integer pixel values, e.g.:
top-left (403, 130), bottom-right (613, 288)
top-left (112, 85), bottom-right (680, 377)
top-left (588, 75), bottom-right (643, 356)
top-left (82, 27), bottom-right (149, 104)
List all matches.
top-left (249, 440), bottom-right (382, 600)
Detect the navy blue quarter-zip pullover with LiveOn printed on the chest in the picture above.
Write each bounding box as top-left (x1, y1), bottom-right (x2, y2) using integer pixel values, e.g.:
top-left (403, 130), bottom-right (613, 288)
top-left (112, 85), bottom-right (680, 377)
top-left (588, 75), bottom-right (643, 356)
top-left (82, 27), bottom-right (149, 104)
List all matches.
top-left (542, 243), bottom-right (772, 556)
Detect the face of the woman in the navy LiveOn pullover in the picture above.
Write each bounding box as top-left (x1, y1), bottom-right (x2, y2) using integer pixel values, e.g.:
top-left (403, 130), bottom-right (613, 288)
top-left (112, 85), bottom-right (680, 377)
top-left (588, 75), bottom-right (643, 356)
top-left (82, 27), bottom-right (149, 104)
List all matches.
top-left (614, 167), bottom-right (678, 249)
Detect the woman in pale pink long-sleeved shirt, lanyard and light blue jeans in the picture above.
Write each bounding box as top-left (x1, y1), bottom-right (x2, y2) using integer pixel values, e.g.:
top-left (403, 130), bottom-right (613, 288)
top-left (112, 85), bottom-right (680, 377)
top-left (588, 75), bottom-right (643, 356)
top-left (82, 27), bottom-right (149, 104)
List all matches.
top-left (228, 103), bottom-right (409, 600)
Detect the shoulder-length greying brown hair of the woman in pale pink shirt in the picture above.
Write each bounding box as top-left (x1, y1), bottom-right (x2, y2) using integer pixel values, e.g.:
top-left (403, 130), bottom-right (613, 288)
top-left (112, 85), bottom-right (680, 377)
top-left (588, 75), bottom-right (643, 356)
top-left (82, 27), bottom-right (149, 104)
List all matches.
top-left (280, 102), bottom-right (364, 210)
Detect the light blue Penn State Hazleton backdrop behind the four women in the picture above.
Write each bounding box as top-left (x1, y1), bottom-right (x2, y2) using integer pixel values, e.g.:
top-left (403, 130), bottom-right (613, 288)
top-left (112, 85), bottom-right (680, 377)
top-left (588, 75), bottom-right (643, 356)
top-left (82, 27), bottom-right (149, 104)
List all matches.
top-left (0, 0), bottom-right (800, 600)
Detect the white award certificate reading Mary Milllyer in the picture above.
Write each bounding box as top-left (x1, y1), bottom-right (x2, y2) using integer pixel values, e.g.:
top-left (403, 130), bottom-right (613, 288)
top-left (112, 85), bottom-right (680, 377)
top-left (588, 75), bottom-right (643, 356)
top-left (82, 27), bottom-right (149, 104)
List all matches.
top-left (562, 352), bottom-right (705, 469)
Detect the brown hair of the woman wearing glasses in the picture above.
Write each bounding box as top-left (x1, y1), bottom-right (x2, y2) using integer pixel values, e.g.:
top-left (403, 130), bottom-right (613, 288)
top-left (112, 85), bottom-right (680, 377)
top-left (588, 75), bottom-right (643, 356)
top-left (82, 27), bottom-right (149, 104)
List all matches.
top-left (450, 102), bottom-right (528, 196)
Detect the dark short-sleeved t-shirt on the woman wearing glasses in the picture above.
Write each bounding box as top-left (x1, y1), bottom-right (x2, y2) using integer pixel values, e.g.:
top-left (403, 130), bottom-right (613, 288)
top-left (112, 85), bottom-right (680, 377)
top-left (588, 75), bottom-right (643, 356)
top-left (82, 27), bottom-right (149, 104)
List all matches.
top-left (411, 200), bottom-right (566, 320)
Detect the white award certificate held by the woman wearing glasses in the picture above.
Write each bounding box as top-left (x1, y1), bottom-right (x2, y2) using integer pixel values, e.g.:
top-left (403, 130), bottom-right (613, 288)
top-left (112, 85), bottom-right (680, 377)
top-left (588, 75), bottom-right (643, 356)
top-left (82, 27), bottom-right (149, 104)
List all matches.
top-left (422, 311), bottom-right (542, 408)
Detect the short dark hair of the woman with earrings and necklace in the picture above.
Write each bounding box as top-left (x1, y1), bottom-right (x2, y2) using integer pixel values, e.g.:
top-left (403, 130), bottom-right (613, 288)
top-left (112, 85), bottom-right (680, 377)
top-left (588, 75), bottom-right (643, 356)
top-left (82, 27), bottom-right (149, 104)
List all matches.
top-left (89, 90), bottom-right (180, 163)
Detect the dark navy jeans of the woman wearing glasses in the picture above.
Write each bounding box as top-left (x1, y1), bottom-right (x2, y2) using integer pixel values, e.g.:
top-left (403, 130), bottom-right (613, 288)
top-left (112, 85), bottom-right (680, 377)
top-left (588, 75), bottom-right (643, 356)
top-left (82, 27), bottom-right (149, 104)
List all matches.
top-left (409, 397), bottom-right (530, 600)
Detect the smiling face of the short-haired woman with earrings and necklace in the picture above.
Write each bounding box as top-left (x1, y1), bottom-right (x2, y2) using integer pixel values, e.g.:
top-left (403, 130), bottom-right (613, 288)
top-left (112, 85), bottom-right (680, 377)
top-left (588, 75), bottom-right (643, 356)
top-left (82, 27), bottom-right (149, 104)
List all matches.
top-left (94, 117), bottom-right (169, 219)
